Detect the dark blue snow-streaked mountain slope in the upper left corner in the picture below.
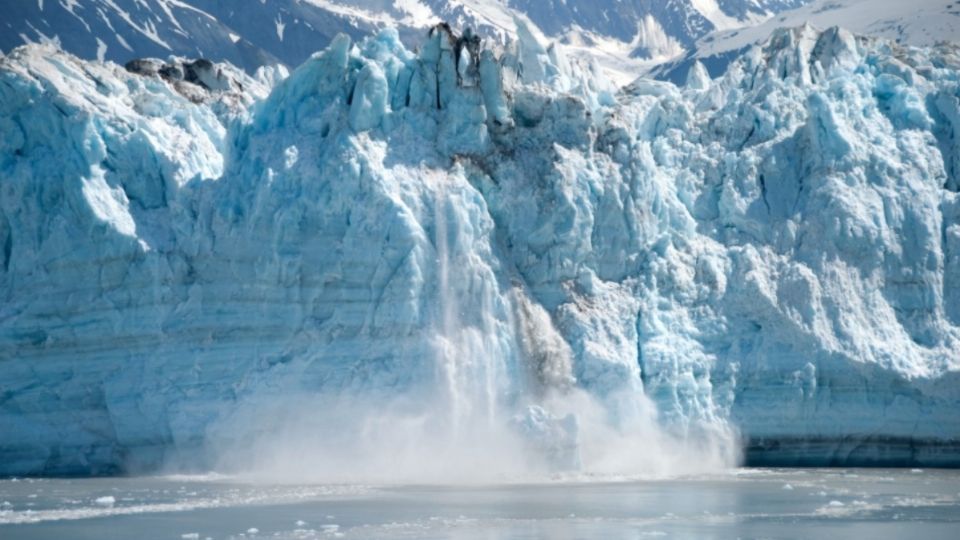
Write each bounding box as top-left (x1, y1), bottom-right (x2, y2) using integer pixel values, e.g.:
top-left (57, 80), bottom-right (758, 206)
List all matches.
top-left (0, 0), bottom-right (394, 72)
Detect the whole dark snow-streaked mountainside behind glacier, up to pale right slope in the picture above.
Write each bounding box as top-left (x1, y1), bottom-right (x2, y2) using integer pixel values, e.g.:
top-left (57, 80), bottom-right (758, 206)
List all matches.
top-left (0, 0), bottom-right (805, 82)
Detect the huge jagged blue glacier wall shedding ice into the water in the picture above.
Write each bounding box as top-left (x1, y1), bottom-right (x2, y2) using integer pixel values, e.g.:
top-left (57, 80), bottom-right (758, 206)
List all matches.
top-left (0, 24), bottom-right (960, 476)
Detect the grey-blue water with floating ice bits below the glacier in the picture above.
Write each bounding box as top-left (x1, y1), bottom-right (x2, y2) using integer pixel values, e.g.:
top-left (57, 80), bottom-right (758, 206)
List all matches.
top-left (0, 469), bottom-right (960, 540)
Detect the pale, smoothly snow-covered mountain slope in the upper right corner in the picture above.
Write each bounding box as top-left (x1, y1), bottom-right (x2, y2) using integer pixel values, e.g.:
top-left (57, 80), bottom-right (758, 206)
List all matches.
top-left (650, 0), bottom-right (960, 82)
